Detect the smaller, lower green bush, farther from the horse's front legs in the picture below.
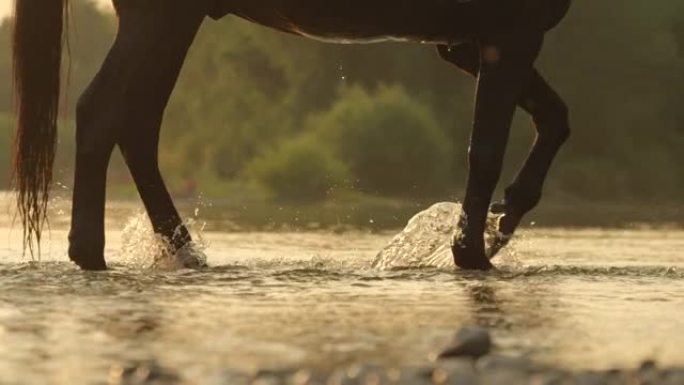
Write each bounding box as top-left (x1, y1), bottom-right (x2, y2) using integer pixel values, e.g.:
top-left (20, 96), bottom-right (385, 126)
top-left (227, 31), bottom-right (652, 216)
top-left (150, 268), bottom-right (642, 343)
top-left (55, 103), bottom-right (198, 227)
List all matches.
top-left (245, 135), bottom-right (347, 203)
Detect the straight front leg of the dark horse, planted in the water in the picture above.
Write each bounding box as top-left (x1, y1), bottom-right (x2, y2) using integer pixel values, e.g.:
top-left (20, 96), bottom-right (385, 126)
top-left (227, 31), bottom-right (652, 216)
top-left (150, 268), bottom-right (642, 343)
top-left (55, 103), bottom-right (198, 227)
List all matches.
top-left (452, 32), bottom-right (542, 270)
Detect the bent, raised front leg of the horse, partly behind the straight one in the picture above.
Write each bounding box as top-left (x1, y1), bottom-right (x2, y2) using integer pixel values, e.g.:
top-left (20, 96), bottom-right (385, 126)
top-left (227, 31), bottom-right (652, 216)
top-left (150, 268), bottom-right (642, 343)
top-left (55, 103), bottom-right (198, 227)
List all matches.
top-left (438, 44), bottom-right (570, 257)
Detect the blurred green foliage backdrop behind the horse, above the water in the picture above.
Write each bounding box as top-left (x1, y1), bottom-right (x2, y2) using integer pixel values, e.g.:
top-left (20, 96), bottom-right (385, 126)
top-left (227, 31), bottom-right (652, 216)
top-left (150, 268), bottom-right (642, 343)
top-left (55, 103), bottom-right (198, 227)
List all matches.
top-left (0, 0), bottom-right (684, 202)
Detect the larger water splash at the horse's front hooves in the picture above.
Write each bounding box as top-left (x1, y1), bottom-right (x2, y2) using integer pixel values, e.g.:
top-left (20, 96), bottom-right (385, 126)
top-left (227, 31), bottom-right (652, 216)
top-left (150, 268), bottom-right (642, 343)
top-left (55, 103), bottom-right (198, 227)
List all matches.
top-left (373, 202), bottom-right (512, 269)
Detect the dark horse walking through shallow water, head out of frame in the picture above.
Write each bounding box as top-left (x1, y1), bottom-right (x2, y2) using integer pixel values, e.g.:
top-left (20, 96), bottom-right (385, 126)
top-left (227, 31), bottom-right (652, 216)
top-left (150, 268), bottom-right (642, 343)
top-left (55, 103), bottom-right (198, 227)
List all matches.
top-left (13, 0), bottom-right (570, 270)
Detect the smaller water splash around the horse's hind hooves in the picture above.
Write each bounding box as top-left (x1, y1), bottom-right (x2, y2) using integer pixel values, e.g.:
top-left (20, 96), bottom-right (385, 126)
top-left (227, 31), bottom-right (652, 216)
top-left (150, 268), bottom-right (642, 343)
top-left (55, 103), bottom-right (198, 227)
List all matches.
top-left (121, 210), bottom-right (208, 270)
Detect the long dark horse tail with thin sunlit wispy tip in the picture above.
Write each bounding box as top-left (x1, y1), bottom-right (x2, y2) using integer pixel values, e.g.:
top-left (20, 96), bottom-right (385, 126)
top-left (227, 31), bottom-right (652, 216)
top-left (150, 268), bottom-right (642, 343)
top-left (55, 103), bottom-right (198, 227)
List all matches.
top-left (12, 0), bottom-right (68, 256)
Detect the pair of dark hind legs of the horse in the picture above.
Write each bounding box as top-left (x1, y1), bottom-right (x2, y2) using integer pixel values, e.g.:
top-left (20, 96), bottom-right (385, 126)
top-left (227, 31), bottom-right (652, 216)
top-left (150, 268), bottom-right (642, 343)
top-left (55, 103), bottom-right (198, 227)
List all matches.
top-left (69, 0), bottom-right (206, 270)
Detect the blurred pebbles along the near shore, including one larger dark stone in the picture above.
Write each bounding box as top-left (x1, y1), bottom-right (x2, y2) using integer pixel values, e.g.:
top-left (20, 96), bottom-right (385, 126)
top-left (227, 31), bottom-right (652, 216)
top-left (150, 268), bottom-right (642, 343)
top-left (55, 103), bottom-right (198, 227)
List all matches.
top-left (103, 334), bottom-right (684, 385)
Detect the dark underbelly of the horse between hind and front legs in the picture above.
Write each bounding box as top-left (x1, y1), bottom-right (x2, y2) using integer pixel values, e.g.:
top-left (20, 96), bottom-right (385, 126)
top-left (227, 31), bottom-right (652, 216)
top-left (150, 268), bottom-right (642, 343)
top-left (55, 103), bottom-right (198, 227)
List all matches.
top-left (228, 0), bottom-right (482, 43)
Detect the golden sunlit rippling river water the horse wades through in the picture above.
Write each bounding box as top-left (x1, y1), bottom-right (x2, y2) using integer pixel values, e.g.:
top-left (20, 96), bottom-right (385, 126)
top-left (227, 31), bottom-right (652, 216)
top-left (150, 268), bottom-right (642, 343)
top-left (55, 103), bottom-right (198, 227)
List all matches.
top-left (0, 200), bottom-right (684, 384)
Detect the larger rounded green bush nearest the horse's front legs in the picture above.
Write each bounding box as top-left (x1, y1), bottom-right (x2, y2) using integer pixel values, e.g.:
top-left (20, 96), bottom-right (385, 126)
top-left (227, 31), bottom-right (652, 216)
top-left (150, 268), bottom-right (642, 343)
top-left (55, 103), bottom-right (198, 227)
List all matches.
top-left (309, 87), bottom-right (452, 196)
